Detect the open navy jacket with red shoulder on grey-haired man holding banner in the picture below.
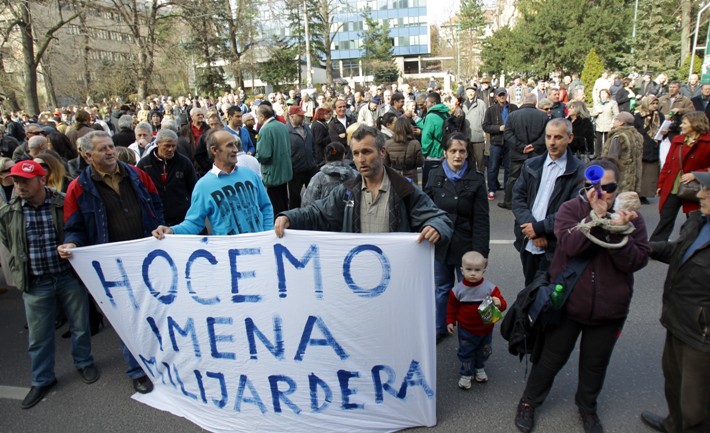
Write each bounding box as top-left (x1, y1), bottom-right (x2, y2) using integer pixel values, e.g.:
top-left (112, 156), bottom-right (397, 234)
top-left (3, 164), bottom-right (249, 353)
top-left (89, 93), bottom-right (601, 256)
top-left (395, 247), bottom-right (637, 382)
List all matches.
top-left (64, 162), bottom-right (163, 247)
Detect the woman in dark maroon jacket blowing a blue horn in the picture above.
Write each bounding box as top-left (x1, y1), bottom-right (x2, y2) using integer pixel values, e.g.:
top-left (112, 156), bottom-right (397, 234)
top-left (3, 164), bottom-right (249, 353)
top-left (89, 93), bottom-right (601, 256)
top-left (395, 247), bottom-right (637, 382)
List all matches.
top-left (515, 158), bottom-right (651, 433)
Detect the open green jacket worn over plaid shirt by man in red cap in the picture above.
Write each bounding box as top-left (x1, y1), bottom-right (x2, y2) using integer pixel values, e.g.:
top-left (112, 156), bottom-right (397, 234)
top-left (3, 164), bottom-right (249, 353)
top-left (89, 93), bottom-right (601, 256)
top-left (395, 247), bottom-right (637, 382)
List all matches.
top-left (0, 190), bottom-right (64, 292)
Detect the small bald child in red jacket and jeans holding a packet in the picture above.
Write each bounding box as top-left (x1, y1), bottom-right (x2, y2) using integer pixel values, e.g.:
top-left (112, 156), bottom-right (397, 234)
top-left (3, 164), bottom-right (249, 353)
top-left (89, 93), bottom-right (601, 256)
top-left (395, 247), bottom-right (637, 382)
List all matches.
top-left (446, 251), bottom-right (508, 389)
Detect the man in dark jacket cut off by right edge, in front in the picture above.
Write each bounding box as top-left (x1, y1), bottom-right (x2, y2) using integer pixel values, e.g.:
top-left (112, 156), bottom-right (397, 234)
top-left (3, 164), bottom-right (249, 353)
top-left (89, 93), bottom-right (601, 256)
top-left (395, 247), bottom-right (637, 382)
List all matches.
top-left (641, 170), bottom-right (710, 433)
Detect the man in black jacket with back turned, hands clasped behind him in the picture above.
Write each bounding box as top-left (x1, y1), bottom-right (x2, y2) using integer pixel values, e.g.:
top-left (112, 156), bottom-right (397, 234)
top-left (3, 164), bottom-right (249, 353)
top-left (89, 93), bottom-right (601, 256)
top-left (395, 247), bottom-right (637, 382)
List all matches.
top-left (498, 94), bottom-right (548, 209)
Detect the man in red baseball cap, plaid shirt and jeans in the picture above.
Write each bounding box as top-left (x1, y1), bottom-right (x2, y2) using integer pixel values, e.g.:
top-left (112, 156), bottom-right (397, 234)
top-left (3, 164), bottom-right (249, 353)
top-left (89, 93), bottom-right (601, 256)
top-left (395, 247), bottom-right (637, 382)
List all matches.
top-left (0, 161), bottom-right (99, 409)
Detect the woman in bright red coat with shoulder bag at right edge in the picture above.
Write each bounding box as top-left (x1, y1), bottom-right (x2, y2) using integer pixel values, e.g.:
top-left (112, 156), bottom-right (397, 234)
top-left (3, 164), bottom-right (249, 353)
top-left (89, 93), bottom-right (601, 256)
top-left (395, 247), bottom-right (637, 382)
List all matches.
top-left (650, 111), bottom-right (710, 242)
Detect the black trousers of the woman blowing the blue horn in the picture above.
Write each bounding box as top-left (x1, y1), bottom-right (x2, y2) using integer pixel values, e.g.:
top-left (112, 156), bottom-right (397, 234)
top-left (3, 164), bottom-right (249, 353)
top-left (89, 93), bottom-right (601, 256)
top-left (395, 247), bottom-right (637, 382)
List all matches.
top-left (521, 315), bottom-right (624, 413)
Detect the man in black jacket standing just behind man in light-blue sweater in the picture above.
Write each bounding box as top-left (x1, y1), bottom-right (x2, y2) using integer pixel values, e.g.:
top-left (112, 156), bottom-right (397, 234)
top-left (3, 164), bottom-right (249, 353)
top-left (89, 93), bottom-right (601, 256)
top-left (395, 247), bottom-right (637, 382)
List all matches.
top-left (138, 129), bottom-right (197, 226)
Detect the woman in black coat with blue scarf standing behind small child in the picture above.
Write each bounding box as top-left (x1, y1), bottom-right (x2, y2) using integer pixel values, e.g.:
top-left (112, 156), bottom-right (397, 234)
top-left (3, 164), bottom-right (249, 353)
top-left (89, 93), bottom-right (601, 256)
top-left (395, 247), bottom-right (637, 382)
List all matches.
top-left (424, 132), bottom-right (490, 342)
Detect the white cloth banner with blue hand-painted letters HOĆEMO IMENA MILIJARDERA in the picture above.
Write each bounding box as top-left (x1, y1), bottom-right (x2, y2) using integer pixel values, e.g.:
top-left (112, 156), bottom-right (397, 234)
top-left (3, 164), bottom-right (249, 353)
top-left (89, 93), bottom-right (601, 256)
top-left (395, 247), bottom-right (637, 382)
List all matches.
top-left (71, 230), bottom-right (436, 433)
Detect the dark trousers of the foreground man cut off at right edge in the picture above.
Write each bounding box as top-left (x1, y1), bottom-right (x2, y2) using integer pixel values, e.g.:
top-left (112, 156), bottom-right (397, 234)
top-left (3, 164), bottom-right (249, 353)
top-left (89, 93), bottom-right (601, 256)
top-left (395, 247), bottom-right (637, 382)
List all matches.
top-left (663, 332), bottom-right (710, 433)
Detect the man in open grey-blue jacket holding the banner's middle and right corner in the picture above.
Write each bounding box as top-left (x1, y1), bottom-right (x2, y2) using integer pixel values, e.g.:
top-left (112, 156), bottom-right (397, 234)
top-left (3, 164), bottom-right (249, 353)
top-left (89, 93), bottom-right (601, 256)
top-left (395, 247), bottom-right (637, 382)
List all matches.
top-left (274, 125), bottom-right (452, 244)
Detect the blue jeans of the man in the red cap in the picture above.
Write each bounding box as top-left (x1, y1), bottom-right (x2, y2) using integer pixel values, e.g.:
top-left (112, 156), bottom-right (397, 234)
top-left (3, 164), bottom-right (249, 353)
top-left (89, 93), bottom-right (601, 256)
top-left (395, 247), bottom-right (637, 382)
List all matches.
top-left (22, 271), bottom-right (94, 386)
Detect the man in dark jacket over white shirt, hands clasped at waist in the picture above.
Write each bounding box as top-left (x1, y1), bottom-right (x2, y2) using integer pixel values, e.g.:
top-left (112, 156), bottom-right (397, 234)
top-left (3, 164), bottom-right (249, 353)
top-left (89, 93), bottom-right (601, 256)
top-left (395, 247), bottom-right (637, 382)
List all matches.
top-left (513, 119), bottom-right (584, 286)
